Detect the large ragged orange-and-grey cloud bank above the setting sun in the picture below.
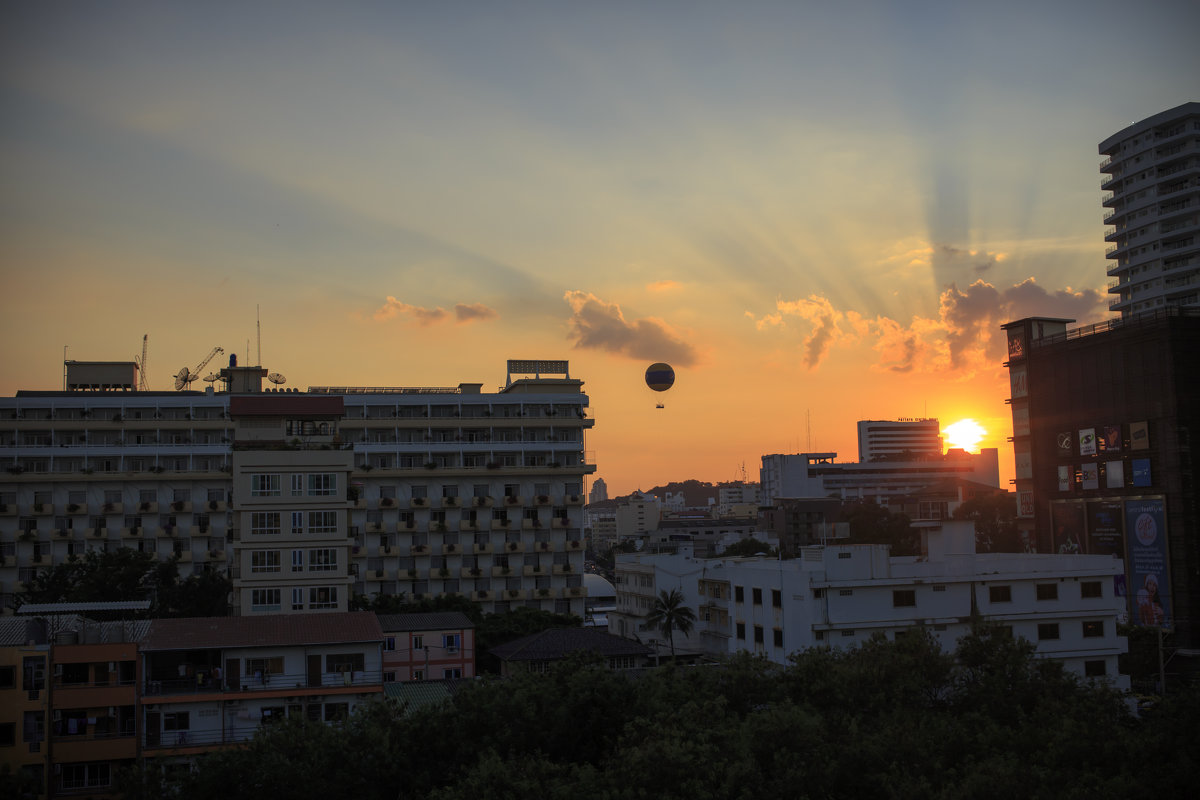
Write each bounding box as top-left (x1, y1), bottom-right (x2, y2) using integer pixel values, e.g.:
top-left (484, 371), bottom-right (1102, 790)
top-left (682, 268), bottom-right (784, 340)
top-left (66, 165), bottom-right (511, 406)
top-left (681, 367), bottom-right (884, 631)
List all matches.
top-left (746, 277), bottom-right (1108, 378)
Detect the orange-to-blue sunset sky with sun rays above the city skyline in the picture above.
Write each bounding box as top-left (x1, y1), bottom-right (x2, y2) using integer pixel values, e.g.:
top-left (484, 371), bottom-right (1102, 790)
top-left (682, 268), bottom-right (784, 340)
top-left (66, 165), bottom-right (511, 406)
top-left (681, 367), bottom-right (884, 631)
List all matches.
top-left (0, 0), bottom-right (1200, 494)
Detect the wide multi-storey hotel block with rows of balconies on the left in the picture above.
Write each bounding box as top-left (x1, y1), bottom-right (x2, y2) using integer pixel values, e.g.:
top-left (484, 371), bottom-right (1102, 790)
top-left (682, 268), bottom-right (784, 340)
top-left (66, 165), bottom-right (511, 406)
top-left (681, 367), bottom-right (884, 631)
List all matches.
top-left (0, 361), bottom-right (595, 616)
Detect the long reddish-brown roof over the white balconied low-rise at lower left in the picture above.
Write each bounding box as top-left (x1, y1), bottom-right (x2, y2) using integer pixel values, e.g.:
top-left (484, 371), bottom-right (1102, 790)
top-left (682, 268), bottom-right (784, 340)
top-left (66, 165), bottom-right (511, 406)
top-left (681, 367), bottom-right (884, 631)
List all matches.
top-left (142, 612), bottom-right (383, 651)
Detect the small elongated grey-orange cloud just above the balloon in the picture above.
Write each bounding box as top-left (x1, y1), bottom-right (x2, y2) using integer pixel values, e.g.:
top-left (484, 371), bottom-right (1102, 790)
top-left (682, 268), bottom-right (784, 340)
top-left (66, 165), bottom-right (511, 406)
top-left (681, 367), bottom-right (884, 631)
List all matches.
top-left (563, 291), bottom-right (697, 367)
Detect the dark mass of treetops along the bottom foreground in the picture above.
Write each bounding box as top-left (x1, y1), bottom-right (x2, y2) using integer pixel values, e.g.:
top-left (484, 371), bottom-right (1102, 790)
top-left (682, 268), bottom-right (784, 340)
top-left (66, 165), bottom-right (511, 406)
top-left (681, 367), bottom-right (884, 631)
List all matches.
top-left (121, 626), bottom-right (1200, 800)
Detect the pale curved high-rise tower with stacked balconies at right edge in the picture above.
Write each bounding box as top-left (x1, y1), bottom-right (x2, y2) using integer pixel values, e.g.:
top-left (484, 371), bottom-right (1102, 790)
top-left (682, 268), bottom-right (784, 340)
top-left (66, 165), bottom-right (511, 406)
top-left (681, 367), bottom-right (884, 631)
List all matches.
top-left (1099, 102), bottom-right (1200, 317)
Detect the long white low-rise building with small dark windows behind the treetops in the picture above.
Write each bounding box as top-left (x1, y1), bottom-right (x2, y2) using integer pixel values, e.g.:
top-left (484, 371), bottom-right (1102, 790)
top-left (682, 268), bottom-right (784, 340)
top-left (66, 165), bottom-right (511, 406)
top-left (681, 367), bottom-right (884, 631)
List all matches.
top-left (686, 523), bottom-right (1128, 688)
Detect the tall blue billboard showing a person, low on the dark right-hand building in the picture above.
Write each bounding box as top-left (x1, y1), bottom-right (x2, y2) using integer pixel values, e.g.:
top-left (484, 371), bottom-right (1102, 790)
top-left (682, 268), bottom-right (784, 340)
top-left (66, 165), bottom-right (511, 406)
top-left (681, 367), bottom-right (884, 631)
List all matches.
top-left (1124, 499), bottom-right (1171, 626)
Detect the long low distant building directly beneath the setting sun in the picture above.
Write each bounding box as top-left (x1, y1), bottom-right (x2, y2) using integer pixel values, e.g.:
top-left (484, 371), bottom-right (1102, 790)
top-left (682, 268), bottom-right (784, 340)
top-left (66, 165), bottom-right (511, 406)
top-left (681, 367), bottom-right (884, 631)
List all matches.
top-left (760, 447), bottom-right (1000, 504)
